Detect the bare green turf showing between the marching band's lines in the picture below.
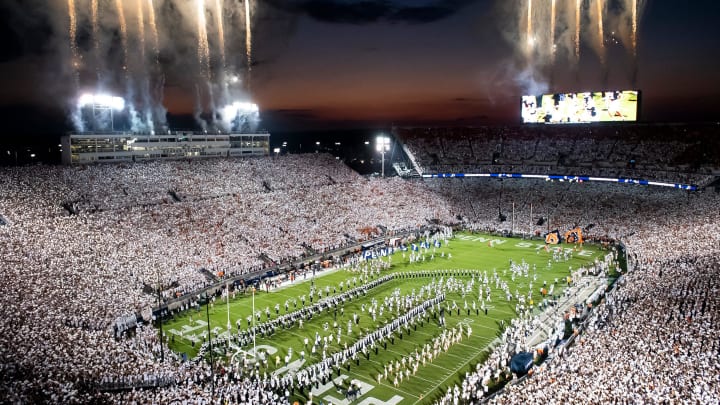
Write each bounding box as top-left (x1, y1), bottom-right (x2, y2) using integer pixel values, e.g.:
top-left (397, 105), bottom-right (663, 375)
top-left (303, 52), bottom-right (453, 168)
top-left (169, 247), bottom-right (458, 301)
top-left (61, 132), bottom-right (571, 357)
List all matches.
top-left (163, 233), bottom-right (604, 405)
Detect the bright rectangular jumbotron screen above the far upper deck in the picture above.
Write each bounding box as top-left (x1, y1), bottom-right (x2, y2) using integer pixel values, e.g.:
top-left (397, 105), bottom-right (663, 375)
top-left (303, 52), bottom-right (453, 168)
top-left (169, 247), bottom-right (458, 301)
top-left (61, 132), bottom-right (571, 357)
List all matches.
top-left (522, 90), bottom-right (640, 124)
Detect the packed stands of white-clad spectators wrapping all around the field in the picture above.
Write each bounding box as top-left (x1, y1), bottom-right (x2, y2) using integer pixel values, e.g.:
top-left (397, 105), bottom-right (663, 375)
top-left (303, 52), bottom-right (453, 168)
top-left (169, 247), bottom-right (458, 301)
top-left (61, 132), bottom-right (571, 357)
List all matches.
top-left (0, 126), bottom-right (720, 404)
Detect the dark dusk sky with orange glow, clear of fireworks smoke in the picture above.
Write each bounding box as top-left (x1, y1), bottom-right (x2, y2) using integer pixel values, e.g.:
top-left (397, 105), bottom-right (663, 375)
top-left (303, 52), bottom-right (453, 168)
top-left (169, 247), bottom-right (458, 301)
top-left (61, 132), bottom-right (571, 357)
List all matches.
top-left (0, 0), bottom-right (720, 137)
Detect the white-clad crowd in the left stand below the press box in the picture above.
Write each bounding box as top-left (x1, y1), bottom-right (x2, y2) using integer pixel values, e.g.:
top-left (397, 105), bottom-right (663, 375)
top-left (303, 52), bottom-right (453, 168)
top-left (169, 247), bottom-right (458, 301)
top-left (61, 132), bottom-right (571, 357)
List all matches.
top-left (0, 155), bottom-right (450, 403)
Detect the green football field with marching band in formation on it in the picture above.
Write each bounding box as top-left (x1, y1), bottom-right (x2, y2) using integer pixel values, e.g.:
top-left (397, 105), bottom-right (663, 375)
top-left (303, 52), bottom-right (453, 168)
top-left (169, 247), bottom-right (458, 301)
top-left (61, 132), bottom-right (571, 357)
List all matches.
top-left (163, 233), bottom-right (608, 405)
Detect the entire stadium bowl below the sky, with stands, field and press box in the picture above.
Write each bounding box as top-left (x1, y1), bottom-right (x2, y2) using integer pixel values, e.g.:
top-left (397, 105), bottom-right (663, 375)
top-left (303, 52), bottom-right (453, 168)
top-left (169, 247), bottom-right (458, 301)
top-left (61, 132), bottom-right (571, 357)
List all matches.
top-left (0, 90), bottom-right (720, 405)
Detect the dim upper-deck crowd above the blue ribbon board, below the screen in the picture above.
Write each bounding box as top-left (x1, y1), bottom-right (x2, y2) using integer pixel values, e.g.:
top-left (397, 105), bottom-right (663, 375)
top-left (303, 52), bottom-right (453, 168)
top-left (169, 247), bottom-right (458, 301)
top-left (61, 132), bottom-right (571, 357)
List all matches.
top-left (396, 125), bottom-right (720, 184)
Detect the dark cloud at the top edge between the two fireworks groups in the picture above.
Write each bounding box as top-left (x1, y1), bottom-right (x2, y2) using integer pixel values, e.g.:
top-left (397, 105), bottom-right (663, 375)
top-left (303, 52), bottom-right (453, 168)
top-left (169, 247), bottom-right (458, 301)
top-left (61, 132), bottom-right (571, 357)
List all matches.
top-left (268, 0), bottom-right (477, 24)
